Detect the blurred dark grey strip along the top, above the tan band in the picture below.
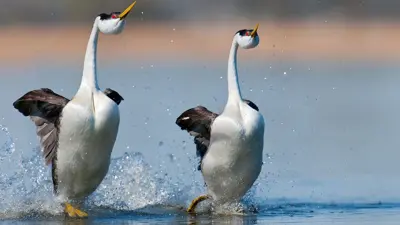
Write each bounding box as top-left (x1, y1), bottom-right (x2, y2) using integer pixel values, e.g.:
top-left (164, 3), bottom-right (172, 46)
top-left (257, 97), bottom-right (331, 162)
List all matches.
top-left (0, 0), bottom-right (400, 22)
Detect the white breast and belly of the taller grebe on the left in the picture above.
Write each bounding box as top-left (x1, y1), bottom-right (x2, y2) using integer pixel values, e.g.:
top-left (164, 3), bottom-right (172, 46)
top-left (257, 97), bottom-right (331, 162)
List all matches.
top-left (57, 91), bottom-right (119, 198)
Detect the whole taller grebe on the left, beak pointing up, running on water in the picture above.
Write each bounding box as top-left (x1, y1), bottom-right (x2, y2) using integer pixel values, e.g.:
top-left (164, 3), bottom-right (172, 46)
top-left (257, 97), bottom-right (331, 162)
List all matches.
top-left (14, 2), bottom-right (136, 217)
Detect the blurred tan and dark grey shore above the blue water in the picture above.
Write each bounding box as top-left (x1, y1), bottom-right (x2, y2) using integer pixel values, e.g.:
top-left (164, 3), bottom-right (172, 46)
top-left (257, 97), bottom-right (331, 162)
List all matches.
top-left (0, 0), bottom-right (400, 63)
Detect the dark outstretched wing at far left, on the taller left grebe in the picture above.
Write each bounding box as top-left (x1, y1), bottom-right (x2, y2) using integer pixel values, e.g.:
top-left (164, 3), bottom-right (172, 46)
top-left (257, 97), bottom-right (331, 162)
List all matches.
top-left (13, 88), bottom-right (69, 165)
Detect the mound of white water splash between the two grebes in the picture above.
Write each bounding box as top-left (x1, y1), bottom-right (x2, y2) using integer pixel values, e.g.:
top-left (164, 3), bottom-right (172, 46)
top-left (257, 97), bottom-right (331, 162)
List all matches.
top-left (89, 152), bottom-right (191, 211)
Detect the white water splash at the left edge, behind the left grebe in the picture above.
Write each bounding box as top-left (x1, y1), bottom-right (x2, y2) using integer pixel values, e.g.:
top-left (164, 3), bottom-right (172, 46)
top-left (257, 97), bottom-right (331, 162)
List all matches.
top-left (0, 125), bottom-right (60, 218)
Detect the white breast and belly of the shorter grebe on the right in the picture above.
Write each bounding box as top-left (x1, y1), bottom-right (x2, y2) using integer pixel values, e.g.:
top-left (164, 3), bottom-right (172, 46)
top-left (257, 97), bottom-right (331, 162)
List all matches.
top-left (202, 105), bottom-right (264, 204)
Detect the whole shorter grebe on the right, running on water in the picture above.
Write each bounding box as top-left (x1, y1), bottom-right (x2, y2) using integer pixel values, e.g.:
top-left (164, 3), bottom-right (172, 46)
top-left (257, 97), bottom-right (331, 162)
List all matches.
top-left (177, 24), bottom-right (265, 212)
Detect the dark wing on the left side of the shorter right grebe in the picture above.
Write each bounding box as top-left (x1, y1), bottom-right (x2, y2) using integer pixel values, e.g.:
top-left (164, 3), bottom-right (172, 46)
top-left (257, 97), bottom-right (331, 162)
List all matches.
top-left (176, 106), bottom-right (218, 170)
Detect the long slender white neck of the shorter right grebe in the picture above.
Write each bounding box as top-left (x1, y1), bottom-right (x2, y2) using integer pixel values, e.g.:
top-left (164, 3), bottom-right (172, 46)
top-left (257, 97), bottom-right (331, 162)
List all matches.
top-left (228, 40), bottom-right (242, 103)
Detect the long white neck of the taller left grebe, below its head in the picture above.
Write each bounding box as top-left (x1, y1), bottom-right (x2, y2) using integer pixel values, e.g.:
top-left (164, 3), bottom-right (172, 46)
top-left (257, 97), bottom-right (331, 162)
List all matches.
top-left (79, 20), bottom-right (99, 90)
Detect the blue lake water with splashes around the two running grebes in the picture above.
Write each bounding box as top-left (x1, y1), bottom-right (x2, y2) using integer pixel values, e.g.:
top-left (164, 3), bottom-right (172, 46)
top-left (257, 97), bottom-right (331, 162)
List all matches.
top-left (0, 61), bottom-right (400, 224)
